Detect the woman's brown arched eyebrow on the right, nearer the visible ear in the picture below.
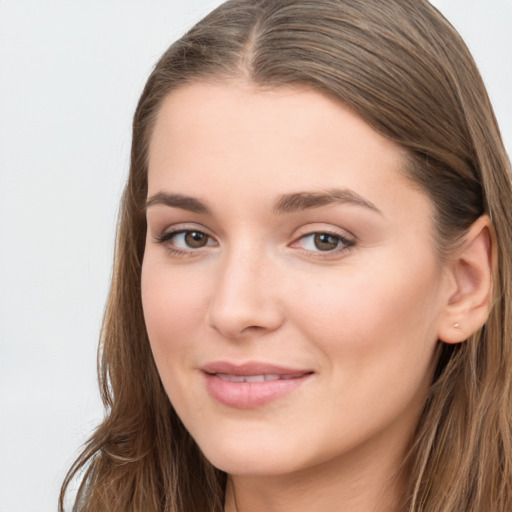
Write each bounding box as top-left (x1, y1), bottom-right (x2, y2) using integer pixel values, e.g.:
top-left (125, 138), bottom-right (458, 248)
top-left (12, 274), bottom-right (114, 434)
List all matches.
top-left (272, 188), bottom-right (383, 215)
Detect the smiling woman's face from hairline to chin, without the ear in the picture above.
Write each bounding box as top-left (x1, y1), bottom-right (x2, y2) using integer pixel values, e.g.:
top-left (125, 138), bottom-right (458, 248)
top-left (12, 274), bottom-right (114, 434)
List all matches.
top-left (142, 83), bottom-right (449, 475)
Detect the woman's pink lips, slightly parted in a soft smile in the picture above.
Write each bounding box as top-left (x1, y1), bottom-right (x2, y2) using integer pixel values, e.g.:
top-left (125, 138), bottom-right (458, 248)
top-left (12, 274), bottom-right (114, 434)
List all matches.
top-left (201, 361), bottom-right (313, 409)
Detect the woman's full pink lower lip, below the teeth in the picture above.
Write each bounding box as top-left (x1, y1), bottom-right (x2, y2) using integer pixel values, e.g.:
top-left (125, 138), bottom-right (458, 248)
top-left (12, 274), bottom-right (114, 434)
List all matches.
top-left (205, 373), bottom-right (311, 409)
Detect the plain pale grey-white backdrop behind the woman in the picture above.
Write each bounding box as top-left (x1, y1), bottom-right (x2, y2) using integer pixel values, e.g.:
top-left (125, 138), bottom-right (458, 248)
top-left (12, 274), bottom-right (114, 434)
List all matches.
top-left (0, 0), bottom-right (512, 512)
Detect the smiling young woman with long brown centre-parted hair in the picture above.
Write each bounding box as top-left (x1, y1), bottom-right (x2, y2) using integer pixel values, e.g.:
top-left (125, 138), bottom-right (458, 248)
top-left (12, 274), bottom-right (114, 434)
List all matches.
top-left (61, 0), bottom-right (512, 512)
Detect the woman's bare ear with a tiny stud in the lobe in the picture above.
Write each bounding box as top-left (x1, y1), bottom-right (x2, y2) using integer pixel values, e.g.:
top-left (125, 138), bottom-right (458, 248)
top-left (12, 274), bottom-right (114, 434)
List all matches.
top-left (438, 215), bottom-right (496, 343)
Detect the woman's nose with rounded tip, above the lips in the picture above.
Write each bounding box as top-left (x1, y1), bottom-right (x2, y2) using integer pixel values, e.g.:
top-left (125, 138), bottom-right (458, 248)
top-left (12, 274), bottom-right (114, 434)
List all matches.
top-left (207, 250), bottom-right (283, 339)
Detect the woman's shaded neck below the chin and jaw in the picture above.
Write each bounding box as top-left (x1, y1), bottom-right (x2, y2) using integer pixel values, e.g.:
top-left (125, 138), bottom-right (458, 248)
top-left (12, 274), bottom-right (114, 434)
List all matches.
top-left (225, 436), bottom-right (404, 512)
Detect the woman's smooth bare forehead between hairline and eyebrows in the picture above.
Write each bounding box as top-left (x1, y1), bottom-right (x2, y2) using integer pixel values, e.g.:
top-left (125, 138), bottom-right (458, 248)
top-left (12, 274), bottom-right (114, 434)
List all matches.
top-left (148, 82), bottom-right (425, 221)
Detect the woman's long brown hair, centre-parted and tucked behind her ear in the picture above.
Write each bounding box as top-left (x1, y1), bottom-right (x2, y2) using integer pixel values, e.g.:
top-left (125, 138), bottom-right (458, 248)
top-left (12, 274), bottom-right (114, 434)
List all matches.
top-left (60, 0), bottom-right (512, 512)
